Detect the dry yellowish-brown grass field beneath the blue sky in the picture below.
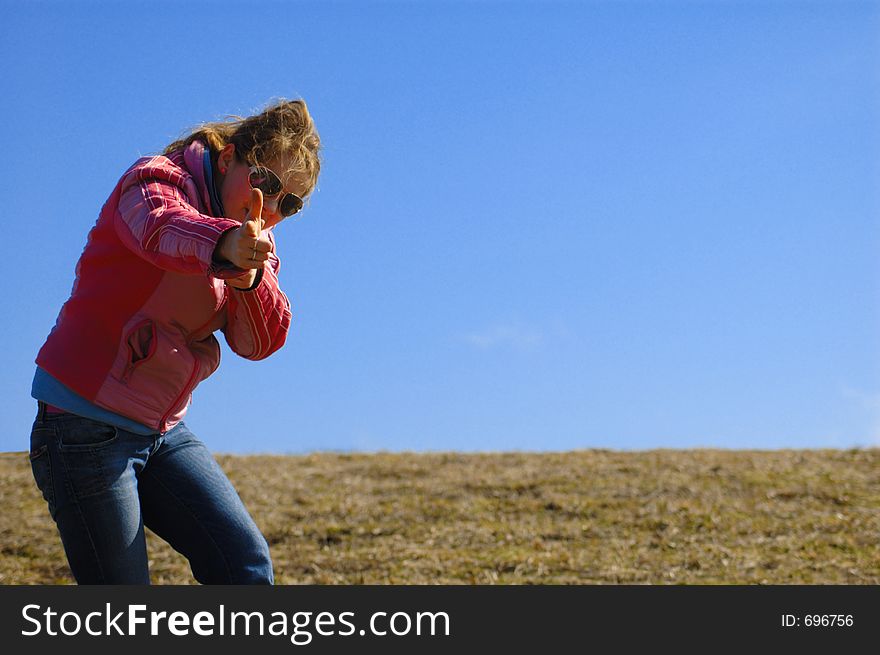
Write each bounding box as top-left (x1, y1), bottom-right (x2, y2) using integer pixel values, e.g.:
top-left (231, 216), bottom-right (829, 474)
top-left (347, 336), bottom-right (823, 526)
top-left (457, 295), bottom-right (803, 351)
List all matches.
top-left (0, 449), bottom-right (880, 584)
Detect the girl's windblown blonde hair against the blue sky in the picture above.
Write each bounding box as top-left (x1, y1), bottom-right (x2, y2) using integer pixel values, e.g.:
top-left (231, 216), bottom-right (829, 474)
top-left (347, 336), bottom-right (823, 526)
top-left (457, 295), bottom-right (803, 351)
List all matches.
top-left (162, 100), bottom-right (321, 195)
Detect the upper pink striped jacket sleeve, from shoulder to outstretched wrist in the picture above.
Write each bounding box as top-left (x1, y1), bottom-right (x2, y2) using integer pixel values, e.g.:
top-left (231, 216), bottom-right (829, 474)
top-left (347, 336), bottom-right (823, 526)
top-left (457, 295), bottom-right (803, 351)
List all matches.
top-left (115, 160), bottom-right (239, 277)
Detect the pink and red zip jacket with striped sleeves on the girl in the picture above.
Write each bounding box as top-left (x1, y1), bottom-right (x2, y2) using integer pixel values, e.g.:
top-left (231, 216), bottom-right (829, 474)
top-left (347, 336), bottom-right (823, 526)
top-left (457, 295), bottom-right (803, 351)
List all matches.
top-left (36, 141), bottom-right (291, 432)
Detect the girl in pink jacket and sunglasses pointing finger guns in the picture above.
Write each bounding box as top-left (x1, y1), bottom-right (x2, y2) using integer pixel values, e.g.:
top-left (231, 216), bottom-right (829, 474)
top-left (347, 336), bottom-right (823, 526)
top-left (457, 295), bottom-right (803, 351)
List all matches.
top-left (30, 100), bottom-right (320, 584)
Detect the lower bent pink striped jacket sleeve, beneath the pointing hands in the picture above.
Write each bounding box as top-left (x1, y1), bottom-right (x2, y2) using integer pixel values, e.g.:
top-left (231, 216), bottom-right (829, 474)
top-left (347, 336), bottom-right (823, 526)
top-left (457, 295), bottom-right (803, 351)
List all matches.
top-left (223, 243), bottom-right (291, 360)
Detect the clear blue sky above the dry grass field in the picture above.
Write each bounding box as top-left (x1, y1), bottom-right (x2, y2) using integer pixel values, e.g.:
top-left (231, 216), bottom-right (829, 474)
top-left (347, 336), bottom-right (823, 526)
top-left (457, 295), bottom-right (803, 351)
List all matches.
top-left (0, 1), bottom-right (880, 453)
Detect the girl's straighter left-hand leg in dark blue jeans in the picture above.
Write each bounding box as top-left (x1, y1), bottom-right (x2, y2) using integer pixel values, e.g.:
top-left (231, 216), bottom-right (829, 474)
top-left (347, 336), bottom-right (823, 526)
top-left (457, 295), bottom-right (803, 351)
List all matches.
top-left (30, 403), bottom-right (152, 584)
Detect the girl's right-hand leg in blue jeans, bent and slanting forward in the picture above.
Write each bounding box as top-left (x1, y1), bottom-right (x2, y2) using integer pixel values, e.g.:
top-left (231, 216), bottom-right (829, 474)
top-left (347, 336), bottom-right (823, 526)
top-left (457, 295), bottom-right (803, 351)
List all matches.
top-left (138, 423), bottom-right (274, 584)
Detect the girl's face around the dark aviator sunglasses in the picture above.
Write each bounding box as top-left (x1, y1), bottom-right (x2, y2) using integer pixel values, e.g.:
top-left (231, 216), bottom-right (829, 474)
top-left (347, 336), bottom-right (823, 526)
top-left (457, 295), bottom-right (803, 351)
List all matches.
top-left (217, 143), bottom-right (306, 229)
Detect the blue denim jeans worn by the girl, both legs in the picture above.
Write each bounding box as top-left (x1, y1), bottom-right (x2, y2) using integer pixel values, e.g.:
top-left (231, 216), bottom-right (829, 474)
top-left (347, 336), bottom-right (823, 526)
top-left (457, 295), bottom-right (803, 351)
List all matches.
top-left (30, 403), bottom-right (274, 584)
